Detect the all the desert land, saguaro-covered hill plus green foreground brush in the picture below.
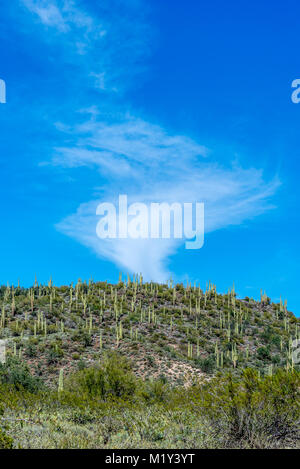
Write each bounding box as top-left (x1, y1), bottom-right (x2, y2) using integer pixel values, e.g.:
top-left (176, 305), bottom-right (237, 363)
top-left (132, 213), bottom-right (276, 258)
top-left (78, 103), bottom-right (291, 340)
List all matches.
top-left (0, 275), bottom-right (300, 448)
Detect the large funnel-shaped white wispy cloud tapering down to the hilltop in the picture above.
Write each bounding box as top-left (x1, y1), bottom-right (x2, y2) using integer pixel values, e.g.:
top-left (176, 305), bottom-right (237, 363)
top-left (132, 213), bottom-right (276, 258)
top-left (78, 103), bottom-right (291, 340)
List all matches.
top-left (54, 112), bottom-right (280, 281)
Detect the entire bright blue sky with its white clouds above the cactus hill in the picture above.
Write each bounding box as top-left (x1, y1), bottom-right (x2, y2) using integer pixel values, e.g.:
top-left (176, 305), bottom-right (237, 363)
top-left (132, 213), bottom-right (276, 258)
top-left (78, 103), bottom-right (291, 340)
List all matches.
top-left (0, 0), bottom-right (300, 315)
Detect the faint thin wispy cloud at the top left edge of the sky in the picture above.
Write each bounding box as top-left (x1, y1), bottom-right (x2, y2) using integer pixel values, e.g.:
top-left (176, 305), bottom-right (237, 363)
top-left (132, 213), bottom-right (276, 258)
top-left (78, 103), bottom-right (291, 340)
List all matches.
top-left (19, 0), bottom-right (150, 93)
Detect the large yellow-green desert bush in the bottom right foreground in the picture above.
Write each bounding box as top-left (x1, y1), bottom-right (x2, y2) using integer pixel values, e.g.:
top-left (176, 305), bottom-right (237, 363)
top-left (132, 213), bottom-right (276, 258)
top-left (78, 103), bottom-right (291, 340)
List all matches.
top-left (200, 369), bottom-right (300, 448)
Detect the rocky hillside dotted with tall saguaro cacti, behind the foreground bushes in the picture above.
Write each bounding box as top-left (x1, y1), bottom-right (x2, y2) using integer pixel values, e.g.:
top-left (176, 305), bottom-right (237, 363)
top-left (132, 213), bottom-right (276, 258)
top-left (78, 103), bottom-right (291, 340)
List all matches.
top-left (0, 276), bottom-right (300, 387)
